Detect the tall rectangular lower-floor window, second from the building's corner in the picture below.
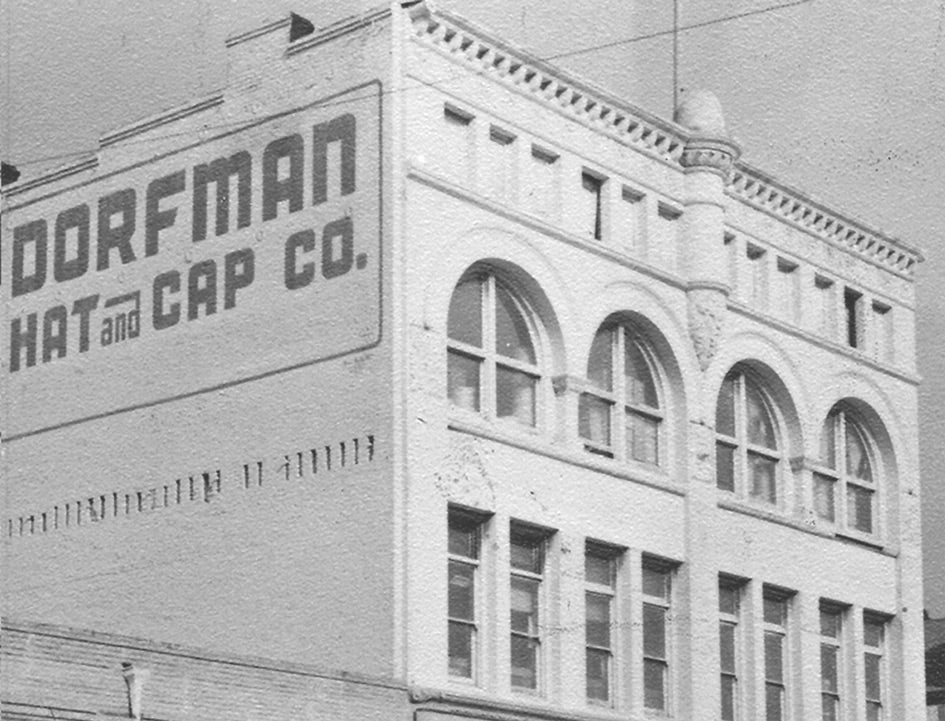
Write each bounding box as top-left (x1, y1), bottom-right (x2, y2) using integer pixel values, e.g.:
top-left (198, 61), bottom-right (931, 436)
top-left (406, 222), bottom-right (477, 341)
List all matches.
top-left (510, 524), bottom-right (546, 691)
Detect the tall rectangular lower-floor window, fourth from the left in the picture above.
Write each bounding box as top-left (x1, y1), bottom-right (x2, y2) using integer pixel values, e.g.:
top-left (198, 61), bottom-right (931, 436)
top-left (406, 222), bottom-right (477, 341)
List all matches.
top-left (643, 557), bottom-right (672, 711)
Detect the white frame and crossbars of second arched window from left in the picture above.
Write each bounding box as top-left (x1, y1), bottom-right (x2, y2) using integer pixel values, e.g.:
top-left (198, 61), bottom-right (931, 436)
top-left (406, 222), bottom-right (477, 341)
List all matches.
top-left (578, 321), bottom-right (668, 469)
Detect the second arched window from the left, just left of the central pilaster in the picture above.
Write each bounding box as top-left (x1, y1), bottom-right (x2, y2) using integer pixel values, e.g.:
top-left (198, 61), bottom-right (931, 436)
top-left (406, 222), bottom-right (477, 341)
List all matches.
top-left (579, 325), bottom-right (663, 465)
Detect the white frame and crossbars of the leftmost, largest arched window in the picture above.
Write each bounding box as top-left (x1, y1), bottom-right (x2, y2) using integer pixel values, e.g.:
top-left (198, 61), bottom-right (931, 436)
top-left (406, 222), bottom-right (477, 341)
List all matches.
top-left (446, 267), bottom-right (549, 432)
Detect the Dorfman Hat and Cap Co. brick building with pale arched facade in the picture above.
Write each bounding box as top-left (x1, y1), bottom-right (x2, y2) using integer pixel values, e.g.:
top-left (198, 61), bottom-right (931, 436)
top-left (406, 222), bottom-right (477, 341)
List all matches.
top-left (2, 2), bottom-right (925, 721)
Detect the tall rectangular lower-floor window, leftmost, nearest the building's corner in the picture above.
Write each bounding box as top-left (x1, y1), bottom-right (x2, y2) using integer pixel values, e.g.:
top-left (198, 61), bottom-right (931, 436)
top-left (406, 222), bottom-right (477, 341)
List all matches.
top-left (447, 508), bottom-right (484, 680)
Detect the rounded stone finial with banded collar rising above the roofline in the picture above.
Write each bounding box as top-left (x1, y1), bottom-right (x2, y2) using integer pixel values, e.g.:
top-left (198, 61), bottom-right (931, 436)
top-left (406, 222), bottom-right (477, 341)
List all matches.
top-left (673, 90), bottom-right (741, 181)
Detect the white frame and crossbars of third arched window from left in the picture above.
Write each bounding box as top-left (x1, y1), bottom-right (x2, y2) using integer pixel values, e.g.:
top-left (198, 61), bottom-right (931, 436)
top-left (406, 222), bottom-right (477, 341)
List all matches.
top-left (715, 365), bottom-right (788, 510)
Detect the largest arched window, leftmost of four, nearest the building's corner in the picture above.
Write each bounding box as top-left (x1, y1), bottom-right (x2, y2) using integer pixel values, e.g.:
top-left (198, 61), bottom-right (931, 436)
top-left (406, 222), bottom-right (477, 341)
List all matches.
top-left (447, 272), bottom-right (541, 426)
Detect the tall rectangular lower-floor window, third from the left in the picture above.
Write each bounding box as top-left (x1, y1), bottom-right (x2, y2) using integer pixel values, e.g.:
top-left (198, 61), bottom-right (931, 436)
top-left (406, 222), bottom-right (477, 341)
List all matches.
top-left (584, 543), bottom-right (617, 705)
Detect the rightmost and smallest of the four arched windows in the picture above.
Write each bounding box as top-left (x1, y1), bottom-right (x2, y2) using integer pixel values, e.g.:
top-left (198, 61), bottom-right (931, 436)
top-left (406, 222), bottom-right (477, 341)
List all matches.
top-left (814, 406), bottom-right (876, 533)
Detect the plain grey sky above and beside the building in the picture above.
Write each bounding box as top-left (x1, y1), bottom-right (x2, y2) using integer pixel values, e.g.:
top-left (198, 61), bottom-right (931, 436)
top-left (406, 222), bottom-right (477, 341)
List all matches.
top-left (0, 0), bottom-right (945, 617)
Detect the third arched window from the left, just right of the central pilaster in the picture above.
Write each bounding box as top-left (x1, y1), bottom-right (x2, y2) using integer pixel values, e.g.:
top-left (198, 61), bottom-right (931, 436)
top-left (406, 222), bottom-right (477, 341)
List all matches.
top-left (715, 368), bottom-right (781, 505)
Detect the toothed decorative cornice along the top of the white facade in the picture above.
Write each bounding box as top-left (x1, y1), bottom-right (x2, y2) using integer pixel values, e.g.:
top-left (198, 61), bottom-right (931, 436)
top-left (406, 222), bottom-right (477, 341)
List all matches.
top-left (407, 2), bottom-right (923, 279)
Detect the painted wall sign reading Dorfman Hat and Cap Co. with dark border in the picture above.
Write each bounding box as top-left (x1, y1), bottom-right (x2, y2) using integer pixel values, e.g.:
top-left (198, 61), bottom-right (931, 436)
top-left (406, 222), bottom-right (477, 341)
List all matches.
top-left (3, 82), bottom-right (382, 439)
